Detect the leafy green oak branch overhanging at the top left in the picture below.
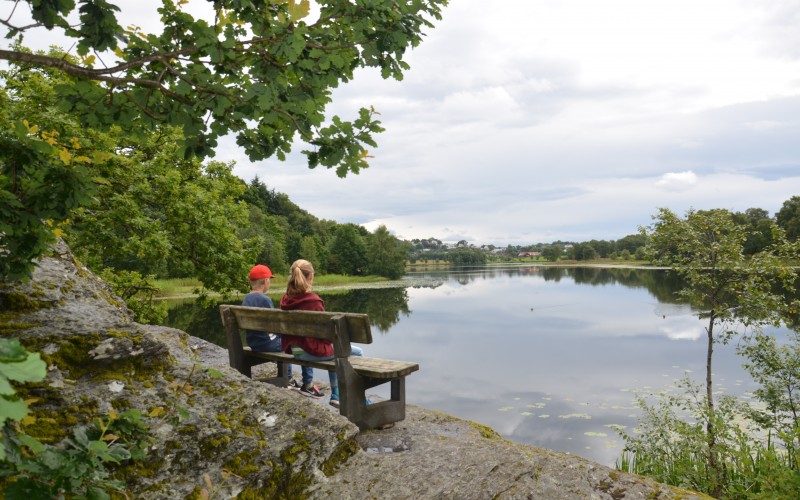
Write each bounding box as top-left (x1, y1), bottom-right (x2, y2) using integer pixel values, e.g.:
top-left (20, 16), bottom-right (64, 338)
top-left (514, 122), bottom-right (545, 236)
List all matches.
top-left (0, 0), bottom-right (447, 164)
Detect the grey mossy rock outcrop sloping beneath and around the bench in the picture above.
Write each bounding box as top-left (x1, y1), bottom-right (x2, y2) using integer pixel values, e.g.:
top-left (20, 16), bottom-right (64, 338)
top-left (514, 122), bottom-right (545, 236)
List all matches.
top-left (0, 244), bottom-right (699, 499)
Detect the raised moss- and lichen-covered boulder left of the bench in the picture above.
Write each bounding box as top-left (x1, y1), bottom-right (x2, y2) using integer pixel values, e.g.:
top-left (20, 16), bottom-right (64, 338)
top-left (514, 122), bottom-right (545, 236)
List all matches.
top-left (0, 243), bottom-right (358, 499)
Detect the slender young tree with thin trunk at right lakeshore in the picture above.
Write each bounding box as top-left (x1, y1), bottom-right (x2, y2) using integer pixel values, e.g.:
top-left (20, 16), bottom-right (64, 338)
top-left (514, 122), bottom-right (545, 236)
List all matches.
top-left (642, 208), bottom-right (797, 497)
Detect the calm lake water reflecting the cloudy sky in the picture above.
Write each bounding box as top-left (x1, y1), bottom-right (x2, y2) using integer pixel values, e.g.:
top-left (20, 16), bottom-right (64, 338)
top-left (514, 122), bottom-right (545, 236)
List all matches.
top-left (159, 265), bottom-right (784, 466)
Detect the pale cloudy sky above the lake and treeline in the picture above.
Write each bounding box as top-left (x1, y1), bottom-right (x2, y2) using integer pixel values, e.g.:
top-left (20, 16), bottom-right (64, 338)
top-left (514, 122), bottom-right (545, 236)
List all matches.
top-left (4, 0), bottom-right (800, 246)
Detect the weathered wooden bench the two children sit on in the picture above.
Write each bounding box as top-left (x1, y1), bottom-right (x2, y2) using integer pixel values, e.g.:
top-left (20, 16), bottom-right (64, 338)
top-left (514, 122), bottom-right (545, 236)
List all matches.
top-left (220, 305), bottom-right (419, 430)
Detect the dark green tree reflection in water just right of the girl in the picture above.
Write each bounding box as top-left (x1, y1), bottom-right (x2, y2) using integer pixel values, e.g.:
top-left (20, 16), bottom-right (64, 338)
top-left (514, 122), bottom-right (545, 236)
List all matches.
top-left (320, 287), bottom-right (411, 333)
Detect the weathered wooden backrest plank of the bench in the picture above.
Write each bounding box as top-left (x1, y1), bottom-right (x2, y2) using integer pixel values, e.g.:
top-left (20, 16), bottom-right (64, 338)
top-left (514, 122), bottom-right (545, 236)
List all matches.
top-left (220, 305), bottom-right (372, 344)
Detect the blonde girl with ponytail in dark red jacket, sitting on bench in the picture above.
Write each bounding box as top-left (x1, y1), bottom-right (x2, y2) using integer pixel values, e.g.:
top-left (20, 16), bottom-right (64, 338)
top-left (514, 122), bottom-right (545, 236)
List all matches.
top-left (281, 259), bottom-right (363, 407)
